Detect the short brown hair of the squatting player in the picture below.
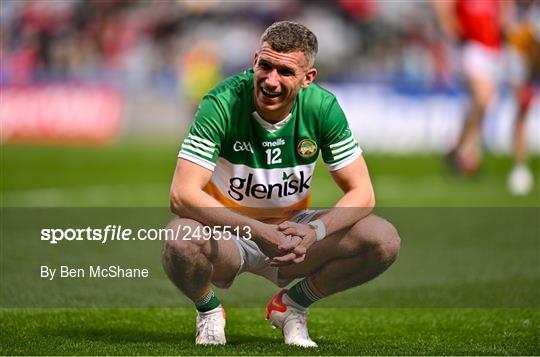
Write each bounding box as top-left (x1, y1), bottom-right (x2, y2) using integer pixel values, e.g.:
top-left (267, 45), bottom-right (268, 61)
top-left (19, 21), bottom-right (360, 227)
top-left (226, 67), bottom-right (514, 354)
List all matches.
top-left (261, 21), bottom-right (319, 67)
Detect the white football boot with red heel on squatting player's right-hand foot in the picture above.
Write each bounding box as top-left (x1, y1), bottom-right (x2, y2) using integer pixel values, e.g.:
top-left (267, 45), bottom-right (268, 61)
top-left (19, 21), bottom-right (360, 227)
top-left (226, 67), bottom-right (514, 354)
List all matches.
top-left (266, 289), bottom-right (318, 347)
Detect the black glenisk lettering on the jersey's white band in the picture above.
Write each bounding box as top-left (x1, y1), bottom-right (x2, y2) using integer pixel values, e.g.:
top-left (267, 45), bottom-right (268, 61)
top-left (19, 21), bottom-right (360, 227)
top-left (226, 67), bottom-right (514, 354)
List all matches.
top-left (227, 171), bottom-right (312, 201)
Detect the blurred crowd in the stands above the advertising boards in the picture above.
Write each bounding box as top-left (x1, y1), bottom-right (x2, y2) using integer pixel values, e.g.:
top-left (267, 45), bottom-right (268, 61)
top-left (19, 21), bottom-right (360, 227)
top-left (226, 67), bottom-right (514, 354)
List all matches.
top-left (0, 0), bottom-right (451, 94)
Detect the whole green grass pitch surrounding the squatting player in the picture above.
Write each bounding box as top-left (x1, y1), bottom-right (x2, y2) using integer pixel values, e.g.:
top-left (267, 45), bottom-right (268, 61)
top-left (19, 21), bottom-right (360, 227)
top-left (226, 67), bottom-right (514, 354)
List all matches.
top-left (0, 145), bottom-right (540, 355)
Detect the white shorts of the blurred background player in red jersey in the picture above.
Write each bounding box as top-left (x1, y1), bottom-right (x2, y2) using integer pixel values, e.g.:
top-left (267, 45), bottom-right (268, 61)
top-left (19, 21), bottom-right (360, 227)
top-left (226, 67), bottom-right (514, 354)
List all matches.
top-left (461, 41), bottom-right (503, 83)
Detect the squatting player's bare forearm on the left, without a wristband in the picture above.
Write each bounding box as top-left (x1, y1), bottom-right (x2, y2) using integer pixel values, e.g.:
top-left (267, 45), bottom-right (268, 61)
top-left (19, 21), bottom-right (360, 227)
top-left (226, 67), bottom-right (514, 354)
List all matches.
top-left (170, 188), bottom-right (263, 237)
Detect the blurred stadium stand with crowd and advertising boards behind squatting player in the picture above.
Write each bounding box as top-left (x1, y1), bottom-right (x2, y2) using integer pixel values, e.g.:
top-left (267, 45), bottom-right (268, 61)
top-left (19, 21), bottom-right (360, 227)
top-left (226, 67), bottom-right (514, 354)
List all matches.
top-left (0, 0), bottom-right (540, 153)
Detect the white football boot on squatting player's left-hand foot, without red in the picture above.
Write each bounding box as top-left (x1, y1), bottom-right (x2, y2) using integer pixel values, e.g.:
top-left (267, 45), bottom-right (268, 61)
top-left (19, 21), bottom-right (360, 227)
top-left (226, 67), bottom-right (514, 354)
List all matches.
top-left (195, 305), bottom-right (227, 346)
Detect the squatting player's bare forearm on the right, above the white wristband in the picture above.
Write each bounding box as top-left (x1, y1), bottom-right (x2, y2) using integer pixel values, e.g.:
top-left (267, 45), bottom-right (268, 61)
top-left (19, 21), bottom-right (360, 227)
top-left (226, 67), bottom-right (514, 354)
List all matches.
top-left (320, 187), bottom-right (375, 236)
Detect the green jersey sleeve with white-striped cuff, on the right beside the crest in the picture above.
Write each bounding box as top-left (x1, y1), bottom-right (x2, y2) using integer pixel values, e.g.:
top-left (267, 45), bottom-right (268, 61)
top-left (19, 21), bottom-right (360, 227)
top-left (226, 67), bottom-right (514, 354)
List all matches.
top-left (321, 98), bottom-right (362, 171)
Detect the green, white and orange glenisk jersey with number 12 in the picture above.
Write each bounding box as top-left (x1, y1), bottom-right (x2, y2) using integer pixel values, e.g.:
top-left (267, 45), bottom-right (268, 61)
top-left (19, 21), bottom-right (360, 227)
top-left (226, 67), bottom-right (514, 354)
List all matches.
top-left (178, 70), bottom-right (362, 220)
